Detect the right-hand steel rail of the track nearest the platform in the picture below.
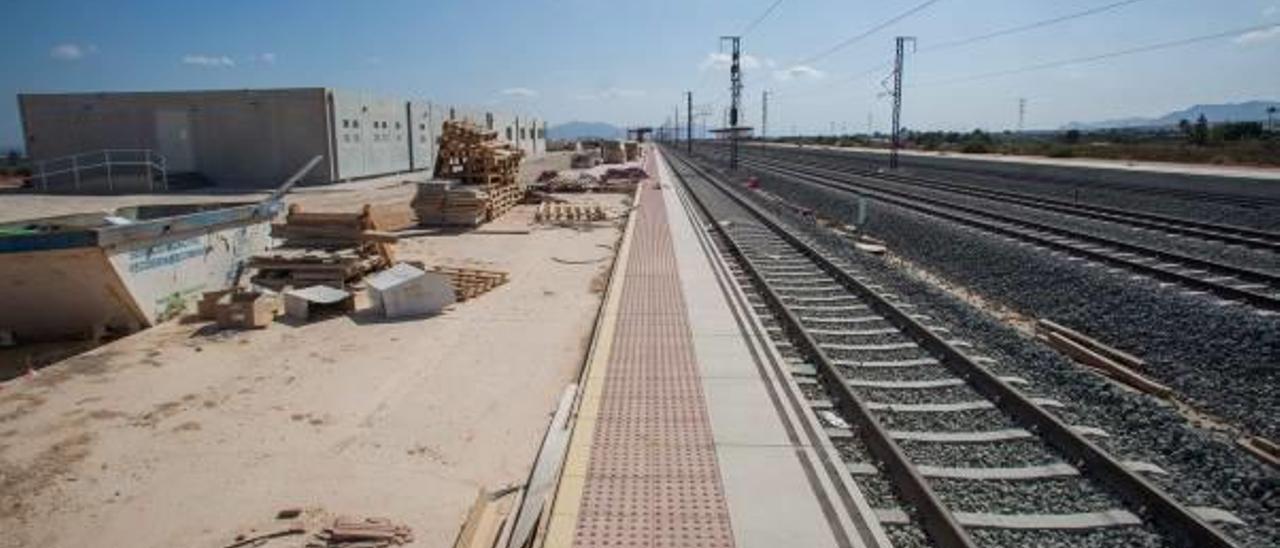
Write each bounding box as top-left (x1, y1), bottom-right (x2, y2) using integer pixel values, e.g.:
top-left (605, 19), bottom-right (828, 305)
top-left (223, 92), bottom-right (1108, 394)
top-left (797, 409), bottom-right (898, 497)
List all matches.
top-left (673, 144), bottom-right (1236, 548)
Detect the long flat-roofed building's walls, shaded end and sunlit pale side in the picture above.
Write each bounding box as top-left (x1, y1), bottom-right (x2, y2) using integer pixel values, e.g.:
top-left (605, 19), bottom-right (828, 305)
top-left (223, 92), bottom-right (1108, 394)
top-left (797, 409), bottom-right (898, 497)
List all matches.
top-left (18, 87), bottom-right (547, 188)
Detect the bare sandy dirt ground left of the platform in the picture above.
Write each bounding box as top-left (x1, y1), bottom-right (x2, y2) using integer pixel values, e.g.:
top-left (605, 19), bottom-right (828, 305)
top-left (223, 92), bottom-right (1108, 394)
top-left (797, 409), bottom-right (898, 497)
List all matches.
top-left (0, 151), bottom-right (640, 548)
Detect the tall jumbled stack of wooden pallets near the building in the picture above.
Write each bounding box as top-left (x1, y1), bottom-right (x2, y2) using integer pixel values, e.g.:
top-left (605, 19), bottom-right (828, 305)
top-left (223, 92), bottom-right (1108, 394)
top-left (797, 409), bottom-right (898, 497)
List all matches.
top-left (435, 120), bottom-right (525, 224)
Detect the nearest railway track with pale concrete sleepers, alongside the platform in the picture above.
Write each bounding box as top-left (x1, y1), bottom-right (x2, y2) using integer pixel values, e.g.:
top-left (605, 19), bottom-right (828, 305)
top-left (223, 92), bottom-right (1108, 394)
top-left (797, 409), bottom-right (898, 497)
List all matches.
top-left (668, 145), bottom-right (1242, 547)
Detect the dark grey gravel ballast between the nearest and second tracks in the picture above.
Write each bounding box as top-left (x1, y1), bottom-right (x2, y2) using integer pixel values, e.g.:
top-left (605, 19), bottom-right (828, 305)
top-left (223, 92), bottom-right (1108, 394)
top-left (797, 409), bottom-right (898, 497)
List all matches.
top-left (675, 145), bottom-right (1280, 547)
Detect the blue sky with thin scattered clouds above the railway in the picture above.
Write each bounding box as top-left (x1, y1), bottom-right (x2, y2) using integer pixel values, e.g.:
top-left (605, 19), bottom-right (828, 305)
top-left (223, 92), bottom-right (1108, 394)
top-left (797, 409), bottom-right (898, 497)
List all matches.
top-left (0, 0), bottom-right (1280, 146)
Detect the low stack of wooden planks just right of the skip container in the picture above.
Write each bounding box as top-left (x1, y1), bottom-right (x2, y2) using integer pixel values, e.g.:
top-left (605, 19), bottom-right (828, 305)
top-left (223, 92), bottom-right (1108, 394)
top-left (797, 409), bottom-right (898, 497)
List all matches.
top-left (248, 205), bottom-right (397, 291)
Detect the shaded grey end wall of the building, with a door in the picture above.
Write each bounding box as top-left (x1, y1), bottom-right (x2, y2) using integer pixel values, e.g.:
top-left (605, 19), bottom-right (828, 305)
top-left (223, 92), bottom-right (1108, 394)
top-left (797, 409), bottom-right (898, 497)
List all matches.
top-left (19, 88), bottom-right (332, 187)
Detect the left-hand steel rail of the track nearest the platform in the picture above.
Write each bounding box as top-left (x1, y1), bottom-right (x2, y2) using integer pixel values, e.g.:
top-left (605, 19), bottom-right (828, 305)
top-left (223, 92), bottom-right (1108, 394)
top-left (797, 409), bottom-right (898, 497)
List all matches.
top-left (664, 149), bottom-right (977, 548)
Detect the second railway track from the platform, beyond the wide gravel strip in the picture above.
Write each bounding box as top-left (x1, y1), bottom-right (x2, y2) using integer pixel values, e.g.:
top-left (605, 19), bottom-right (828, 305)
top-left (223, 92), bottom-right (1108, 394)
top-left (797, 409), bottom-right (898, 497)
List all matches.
top-left (696, 145), bottom-right (1280, 315)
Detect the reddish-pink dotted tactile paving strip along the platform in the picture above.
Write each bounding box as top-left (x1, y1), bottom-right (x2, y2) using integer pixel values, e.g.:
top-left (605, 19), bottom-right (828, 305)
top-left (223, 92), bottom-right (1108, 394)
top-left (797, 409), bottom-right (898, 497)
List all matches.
top-left (573, 154), bottom-right (733, 548)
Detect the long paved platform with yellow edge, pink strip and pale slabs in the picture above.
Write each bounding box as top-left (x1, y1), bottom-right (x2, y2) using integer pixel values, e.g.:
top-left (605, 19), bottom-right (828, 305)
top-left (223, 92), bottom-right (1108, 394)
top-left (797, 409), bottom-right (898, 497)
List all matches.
top-left (543, 149), bottom-right (888, 548)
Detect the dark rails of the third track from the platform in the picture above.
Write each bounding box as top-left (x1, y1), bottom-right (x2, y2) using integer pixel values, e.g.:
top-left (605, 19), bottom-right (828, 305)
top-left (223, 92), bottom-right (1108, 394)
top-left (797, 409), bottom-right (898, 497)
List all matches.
top-left (760, 143), bottom-right (1280, 251)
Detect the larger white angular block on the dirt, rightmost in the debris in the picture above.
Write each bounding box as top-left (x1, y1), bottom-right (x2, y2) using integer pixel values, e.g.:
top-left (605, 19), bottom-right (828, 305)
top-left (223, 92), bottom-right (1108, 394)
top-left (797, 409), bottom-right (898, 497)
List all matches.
top-left (367, 262), bottom-right (457, 318)
